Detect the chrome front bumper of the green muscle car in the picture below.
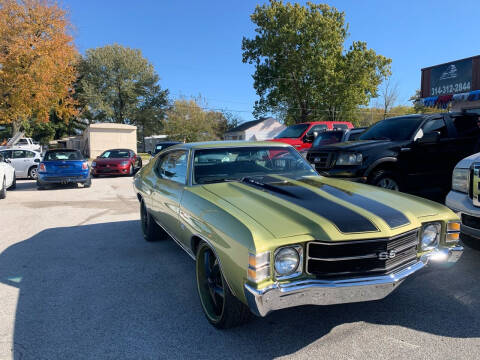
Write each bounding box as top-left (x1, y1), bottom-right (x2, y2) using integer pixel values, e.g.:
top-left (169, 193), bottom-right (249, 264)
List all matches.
top-left (245, 246), bottom-right (463, 316)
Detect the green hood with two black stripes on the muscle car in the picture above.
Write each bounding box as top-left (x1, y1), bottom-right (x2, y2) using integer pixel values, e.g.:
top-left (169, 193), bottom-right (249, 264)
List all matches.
top-left (203, 176), bottom-right (449, 241)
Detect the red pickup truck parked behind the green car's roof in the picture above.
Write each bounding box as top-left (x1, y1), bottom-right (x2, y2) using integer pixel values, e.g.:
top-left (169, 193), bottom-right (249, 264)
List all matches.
top-left (271, 121), bottom-right (353, 151)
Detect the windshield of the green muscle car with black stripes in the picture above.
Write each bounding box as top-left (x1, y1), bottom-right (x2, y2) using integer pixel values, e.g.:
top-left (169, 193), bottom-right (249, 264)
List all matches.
top-left (193, 147), bottom-right (317, 184)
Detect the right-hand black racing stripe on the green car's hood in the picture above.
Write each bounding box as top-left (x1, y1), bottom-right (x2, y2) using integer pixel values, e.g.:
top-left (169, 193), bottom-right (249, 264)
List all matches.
top-left (299, 179), bottom-right (410, 229)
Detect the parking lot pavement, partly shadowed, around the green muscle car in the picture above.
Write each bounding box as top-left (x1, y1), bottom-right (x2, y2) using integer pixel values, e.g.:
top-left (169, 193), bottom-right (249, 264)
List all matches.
top-left (0, 178), bottom-right (480, 360)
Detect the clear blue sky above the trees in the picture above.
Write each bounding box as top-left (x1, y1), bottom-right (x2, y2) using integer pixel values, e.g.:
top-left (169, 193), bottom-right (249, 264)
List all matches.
top-left (61, 0), bottom-right (480, 121)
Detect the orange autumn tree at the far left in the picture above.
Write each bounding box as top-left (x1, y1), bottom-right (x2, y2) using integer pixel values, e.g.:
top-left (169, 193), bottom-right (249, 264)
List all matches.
top-left (0, 0), bottom-right (78, 133)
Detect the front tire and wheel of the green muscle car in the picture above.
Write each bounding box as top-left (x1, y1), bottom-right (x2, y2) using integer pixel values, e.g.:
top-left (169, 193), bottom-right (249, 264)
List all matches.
top-left (196, 243), bottom-right (252, 329)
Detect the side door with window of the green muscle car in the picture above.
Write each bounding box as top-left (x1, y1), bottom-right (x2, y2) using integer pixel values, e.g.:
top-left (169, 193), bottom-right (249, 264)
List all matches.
top-left (150, 150), bottom-right (189, 239)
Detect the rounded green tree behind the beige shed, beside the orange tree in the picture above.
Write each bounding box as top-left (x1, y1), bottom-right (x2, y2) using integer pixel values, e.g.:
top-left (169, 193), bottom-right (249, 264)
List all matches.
top-left (76, 44), bottom-right (168, 137)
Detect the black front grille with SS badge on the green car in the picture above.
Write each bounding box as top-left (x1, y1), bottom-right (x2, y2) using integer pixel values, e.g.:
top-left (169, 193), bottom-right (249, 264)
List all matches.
top-left (306, 230), bottom-right (418, 278)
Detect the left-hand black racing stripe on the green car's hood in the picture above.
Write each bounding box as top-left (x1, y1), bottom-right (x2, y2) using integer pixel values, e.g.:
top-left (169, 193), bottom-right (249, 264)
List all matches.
top-left (243, 178), bottom-right (378, 233)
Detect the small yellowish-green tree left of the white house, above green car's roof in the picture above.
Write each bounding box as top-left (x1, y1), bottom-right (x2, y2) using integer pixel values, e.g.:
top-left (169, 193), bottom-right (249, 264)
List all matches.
top-left (165, 99), bottom-right (228, 142)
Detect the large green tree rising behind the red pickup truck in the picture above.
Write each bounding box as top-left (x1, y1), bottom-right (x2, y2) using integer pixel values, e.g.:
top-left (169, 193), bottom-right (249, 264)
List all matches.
top-left (242, 0), bottom-right (391, 123)
